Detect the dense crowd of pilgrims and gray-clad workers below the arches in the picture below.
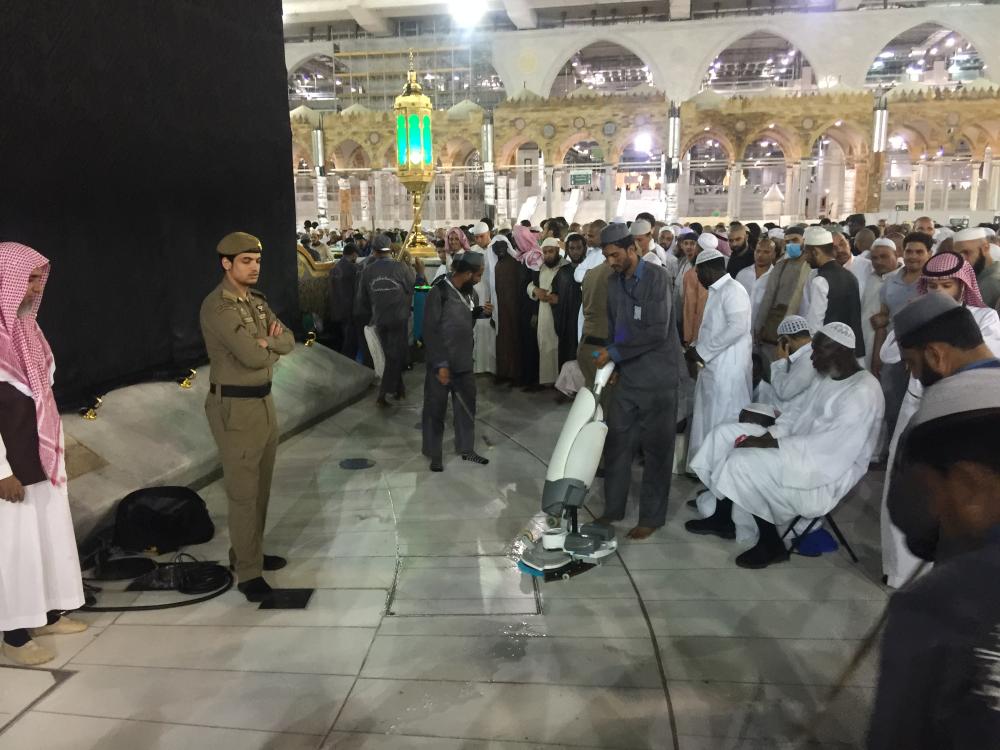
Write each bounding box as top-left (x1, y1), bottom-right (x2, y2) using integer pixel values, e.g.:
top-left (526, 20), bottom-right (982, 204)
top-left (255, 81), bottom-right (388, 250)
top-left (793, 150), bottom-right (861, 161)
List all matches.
top-left (330, 213), bottom-right (1000, 576)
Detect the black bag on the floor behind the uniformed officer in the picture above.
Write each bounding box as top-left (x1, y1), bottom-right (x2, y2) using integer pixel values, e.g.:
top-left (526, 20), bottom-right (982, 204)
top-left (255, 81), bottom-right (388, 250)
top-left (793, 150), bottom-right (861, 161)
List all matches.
top-left (113, 487), bottom-right (215, 554)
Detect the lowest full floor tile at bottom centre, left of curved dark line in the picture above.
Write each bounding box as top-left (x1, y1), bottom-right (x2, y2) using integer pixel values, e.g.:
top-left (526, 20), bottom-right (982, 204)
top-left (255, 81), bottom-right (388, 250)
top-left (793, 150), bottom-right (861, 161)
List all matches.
top-left (335, 679), bottom-right (670, 750)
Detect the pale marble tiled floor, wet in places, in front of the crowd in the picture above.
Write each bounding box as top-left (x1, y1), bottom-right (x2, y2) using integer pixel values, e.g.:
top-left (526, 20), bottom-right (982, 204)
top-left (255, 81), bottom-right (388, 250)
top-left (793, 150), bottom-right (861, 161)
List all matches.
top-left (0, 373), bottom-right (887, 750)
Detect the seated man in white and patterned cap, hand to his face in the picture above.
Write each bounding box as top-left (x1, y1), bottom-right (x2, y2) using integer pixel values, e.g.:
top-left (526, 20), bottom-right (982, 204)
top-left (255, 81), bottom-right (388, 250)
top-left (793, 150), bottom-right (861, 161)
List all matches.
top-left (757, 315), bottom-right (819, 419)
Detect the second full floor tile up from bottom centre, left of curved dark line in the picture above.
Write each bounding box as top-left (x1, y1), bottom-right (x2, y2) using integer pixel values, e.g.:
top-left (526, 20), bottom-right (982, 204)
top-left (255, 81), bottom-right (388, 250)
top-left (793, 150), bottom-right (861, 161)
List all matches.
top-left (361, 632), bottom-right (661, 688)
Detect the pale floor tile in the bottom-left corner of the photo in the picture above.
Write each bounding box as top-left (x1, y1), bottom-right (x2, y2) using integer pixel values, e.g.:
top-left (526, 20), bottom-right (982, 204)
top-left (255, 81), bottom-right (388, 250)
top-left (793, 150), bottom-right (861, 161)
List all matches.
top-left (0, 711), bottom-right (317, 750)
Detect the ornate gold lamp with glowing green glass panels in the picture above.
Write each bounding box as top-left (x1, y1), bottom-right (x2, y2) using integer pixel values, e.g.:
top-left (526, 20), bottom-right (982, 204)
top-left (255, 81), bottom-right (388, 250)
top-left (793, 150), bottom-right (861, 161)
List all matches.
top-left (392, 52), bottom-right (437, 259)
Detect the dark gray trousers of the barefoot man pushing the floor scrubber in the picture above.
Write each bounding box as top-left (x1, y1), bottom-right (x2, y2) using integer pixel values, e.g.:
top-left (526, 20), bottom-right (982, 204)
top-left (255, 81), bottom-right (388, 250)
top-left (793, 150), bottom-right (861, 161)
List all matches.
top-left (604, 383), bottom-right (677, 529)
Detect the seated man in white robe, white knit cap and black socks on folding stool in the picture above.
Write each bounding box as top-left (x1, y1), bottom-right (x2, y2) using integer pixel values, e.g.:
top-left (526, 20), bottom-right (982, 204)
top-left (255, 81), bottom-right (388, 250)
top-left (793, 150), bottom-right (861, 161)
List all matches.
top-left (686, 322), bottom-right (885, 568)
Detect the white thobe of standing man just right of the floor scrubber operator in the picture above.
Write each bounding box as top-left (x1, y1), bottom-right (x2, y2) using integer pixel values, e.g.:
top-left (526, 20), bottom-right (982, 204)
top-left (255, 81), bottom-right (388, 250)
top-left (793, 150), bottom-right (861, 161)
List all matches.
top-left (688, 274), bottom-right (753, 468)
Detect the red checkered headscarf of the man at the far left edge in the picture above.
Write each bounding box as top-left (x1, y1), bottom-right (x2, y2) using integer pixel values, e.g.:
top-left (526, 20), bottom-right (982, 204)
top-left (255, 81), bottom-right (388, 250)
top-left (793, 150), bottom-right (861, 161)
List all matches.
top-left (0, 242), bottom-right (66, 486)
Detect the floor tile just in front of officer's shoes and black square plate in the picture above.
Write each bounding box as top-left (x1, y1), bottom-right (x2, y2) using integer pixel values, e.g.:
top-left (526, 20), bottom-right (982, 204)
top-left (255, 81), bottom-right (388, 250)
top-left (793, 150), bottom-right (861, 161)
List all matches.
top-left (118, 589), bottom-right (389, 628)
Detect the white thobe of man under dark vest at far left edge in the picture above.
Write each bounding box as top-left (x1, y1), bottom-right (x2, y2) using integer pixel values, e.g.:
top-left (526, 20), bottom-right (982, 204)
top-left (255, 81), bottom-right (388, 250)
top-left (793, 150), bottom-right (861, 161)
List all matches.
top-left (0, 373), bottom-right (83, 631)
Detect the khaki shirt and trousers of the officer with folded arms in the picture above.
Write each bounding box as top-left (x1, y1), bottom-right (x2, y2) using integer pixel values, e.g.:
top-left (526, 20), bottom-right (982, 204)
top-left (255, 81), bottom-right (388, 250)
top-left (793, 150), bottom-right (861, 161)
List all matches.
top-left (201, 281), bottom-right (295, 582)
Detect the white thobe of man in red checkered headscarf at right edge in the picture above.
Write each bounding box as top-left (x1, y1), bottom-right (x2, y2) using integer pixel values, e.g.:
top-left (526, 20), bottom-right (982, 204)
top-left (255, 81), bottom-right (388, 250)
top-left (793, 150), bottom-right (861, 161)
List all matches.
top-left (879, 307), bottom-right (1000, 589)
